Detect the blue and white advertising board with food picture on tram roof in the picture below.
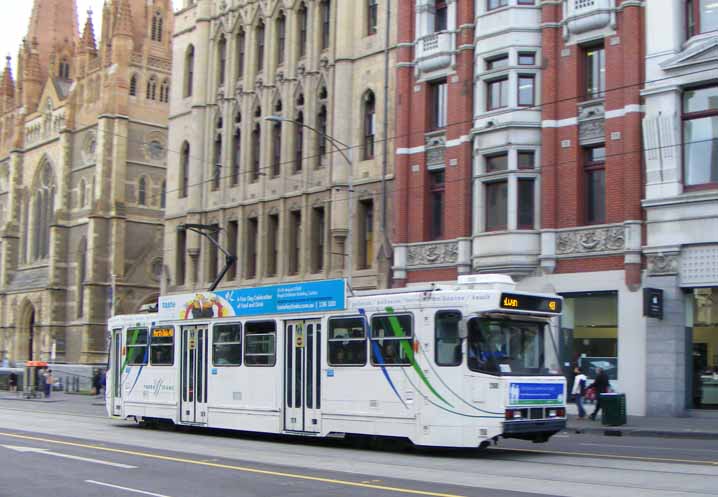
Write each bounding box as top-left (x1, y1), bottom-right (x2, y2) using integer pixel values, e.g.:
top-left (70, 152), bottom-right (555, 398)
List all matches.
top-left (159, 280), bottom-right (346, 320)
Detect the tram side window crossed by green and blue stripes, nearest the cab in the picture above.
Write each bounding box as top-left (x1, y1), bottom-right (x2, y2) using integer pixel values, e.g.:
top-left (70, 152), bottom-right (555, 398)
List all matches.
top-left (371, 314), bottom-right (414, 366)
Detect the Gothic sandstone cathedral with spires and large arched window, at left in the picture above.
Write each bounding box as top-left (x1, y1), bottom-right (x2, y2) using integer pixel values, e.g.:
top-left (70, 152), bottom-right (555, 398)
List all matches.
top-left (0, 0), bottom-right (173, 363)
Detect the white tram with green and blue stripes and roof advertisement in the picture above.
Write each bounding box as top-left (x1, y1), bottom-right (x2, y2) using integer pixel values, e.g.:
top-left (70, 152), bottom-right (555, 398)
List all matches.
top-left (106, 275), bottom-right (566, 447)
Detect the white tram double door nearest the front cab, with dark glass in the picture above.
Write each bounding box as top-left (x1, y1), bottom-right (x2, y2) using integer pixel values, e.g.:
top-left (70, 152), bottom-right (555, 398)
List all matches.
top-left (284, 320), bottom-right (322, 433)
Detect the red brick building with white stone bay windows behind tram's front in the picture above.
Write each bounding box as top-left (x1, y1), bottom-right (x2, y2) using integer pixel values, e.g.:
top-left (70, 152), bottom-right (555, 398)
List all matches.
top-left (393, 0), bottom-right (647, 414)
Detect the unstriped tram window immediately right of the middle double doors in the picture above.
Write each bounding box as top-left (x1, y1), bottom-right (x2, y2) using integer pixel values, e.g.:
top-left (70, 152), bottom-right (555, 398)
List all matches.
top-left (327, 317), bottom-right (366, 366)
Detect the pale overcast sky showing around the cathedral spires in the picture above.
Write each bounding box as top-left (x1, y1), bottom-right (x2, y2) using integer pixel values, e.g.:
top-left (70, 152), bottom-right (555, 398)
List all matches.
top-left (0, 0), bottom-right (176, 76)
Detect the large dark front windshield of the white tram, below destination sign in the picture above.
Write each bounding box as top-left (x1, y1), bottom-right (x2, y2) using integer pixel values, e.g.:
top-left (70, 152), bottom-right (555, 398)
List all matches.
top-left (467, 318), bottom-right (559, 376)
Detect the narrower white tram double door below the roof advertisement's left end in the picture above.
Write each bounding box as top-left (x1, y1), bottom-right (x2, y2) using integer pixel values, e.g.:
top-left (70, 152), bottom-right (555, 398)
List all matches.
top-left (180, 325), bottom-right (208, 424)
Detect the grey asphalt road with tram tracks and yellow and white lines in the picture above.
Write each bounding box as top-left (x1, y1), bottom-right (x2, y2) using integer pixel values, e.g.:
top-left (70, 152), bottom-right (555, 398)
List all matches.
top-left (0, 401), bottom-right (718, 497)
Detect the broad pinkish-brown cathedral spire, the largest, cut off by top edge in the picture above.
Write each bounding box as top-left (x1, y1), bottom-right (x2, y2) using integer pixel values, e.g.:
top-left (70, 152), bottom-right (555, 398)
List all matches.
top-left (26, 0), bottom-right (79, 76)
